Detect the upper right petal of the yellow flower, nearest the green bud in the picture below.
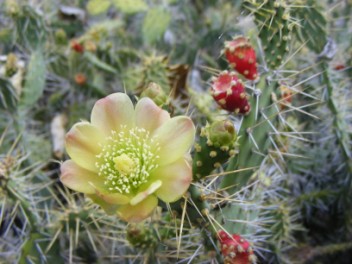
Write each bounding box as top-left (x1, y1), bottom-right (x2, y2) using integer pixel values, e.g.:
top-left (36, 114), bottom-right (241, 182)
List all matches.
top-left (153, 116), bottom-right (195, 165)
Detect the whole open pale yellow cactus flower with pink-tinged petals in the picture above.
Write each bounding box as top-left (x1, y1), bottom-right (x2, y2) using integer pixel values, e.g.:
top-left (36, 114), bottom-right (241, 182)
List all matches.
top-left (60, 93), bottom-right (195, 222)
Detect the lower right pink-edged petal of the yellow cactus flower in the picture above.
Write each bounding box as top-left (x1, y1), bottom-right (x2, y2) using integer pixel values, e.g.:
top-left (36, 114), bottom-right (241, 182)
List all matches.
top-left (151, 158), bottom-right (192, 203)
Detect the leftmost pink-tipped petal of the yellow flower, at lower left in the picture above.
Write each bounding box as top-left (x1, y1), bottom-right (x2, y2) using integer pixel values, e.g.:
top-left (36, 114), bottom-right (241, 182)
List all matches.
top-left (60, 160), bottom-right (104, 194)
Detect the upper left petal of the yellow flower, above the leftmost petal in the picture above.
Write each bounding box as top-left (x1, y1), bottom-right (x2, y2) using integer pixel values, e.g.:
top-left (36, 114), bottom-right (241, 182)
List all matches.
top-left (65, 122), bottom-right (105, 171)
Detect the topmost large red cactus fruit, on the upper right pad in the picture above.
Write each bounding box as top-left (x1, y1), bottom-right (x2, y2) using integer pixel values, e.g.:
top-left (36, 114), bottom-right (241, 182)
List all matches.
top-left (223, 36), bottom-right (258, 80)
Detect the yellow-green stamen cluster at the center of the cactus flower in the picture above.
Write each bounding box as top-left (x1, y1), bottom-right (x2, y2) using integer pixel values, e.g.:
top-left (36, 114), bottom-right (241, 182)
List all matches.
top-left (95, 126), bottom-right (160, 193)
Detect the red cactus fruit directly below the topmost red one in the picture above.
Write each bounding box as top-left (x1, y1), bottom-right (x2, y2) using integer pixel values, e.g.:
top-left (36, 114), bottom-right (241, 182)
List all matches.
top-left (211, 71), bottom-right (251, 114)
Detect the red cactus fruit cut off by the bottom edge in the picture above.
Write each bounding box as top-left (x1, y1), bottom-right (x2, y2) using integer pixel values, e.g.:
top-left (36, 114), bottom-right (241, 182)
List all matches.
top-left (218, 230), bottom-right (257, 264)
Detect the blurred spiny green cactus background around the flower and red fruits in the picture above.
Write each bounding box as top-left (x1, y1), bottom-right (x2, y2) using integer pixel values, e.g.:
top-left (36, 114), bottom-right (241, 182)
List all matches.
top-left (0, 0), bottom-right (352, 263)
